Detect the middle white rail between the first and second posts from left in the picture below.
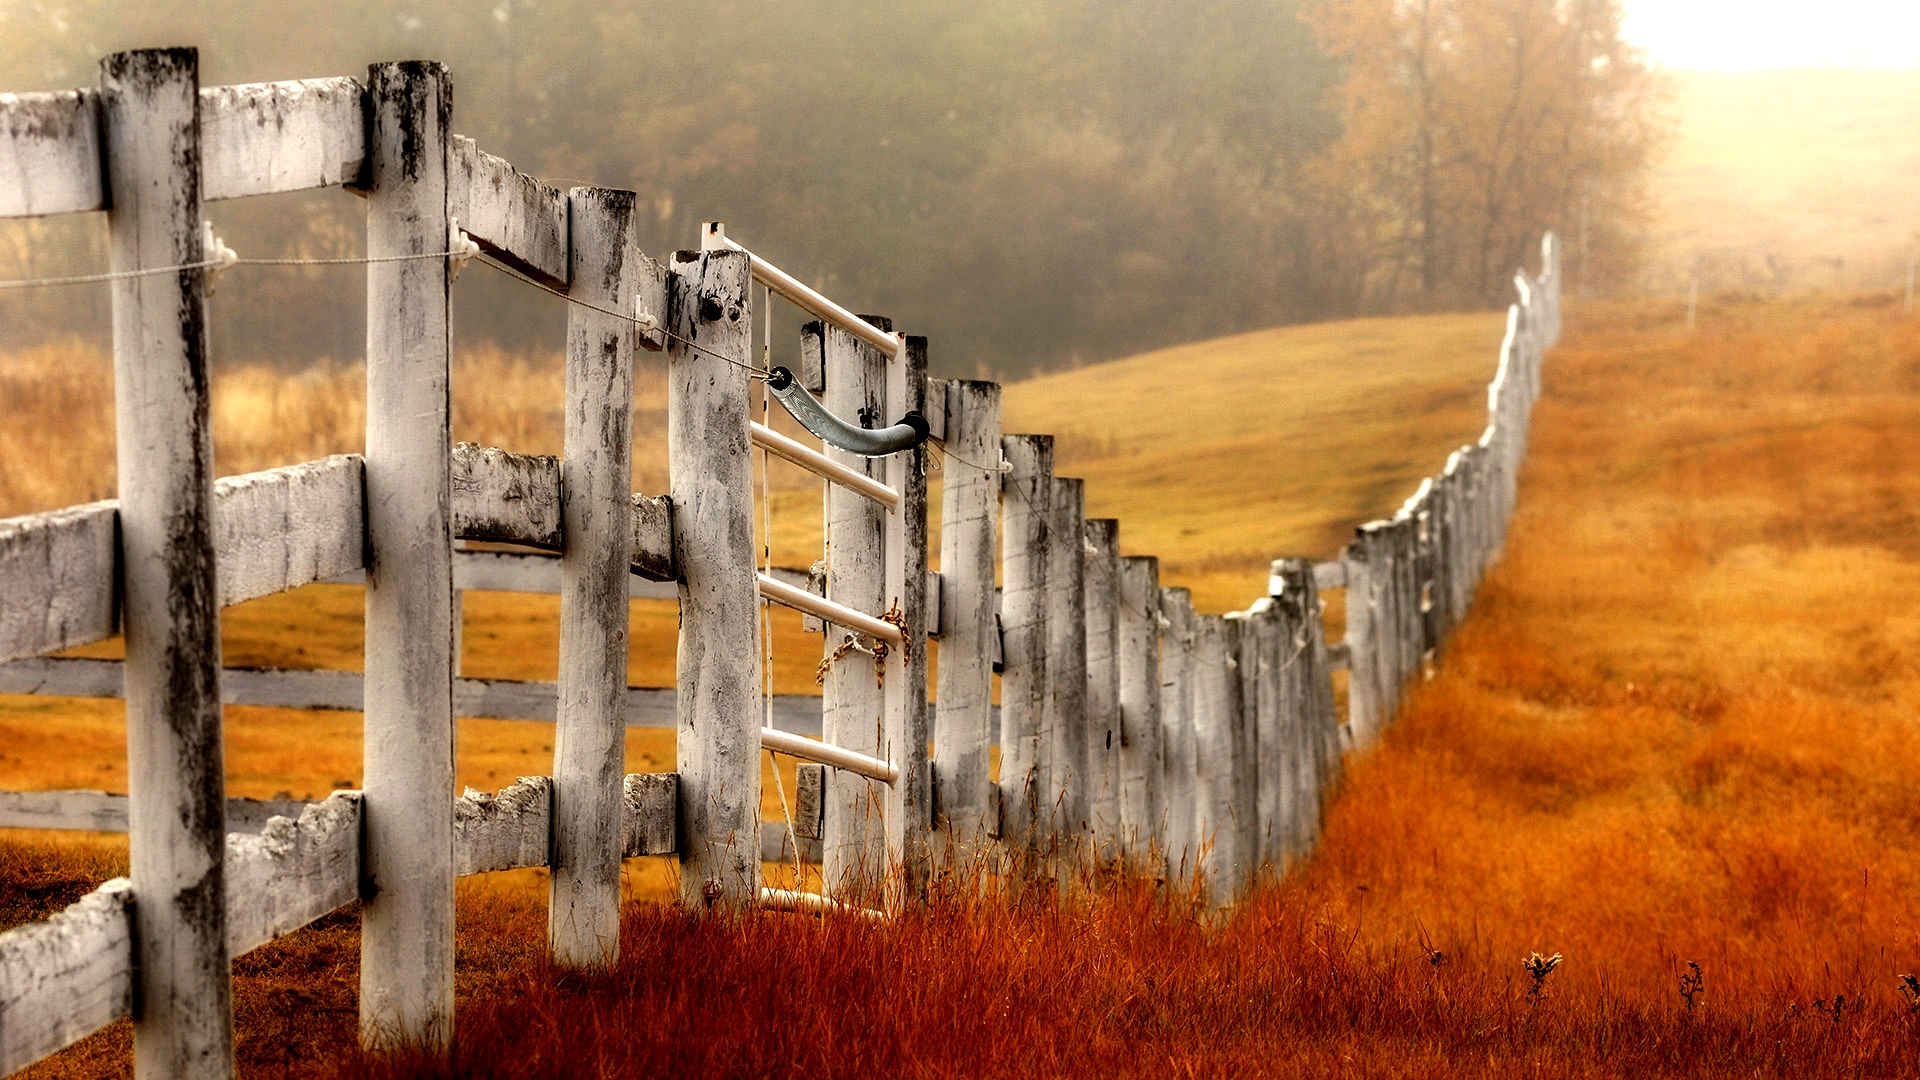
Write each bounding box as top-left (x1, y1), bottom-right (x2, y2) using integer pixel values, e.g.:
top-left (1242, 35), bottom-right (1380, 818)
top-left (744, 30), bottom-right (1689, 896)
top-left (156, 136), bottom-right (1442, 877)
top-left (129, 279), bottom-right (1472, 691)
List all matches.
top-left (213, 454), bottom-right (367, 605)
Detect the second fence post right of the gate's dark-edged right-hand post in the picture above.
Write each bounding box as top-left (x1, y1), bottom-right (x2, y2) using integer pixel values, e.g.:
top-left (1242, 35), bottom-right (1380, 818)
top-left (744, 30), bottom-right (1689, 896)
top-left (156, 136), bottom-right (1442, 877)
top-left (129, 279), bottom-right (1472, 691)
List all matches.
top-left (1000, 434), bottom-right (1054, 853)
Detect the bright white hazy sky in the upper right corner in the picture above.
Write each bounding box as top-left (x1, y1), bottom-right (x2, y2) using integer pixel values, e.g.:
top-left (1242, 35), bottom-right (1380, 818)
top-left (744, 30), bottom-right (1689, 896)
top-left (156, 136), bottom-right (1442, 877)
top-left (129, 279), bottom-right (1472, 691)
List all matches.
top-left (1626, 0), bottom-right (1920, 71)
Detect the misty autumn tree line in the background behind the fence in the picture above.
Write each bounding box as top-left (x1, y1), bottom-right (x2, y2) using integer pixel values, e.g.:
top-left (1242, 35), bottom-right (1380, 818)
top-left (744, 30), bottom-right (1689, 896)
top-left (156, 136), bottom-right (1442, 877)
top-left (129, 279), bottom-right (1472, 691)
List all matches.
top-left (0, 0), bottom-right (1659, 375)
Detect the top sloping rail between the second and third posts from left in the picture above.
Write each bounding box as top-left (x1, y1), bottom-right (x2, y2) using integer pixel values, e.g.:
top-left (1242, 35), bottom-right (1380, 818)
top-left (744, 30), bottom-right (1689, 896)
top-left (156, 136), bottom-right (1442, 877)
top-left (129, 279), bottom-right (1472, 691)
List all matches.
top-left (447, 135), bottom-right (568, 284)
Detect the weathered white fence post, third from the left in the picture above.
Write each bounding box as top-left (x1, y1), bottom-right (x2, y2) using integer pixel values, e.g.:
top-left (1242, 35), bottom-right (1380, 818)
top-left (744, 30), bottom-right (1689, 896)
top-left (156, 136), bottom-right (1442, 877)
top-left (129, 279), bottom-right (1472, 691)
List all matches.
top-left (547, 188), bottom-right (653, 967)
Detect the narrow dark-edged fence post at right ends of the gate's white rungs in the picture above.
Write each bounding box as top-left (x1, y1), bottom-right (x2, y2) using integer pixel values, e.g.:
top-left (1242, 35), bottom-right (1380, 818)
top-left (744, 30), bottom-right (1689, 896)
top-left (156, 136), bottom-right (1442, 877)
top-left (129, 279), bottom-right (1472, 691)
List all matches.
top-left (876, 336), bottom-right (933, 907)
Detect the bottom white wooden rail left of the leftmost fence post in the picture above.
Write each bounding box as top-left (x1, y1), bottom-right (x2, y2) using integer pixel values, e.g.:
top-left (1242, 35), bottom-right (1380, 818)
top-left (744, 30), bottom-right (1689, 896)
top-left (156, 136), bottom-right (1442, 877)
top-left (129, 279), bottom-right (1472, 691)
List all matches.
top-left (0, 878), bottom-right (132, 1074)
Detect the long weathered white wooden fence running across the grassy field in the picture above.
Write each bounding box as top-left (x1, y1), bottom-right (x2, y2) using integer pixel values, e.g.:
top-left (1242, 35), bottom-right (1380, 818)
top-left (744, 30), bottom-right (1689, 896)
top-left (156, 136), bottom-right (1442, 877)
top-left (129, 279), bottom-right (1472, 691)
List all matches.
top-left (0, 50), bottom-right (1559, 1076)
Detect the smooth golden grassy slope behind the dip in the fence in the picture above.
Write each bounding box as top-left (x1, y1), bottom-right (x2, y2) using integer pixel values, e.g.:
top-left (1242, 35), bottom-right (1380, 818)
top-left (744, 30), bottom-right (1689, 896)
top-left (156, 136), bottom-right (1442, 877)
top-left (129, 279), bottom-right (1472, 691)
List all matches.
top-left (1006, 315), bottom-right (1503, 611)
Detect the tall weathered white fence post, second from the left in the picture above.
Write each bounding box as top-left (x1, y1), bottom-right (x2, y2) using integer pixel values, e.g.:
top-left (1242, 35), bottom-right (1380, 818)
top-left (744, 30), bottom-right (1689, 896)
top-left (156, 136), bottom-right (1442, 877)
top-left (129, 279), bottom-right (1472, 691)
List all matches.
top-left (361, 61), bottom-right (453, 1047)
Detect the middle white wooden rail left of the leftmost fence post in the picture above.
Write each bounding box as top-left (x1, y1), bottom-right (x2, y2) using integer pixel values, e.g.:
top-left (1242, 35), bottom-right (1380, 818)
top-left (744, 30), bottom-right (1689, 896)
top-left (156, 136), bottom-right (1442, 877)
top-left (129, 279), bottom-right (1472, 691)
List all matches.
top-left (0, 502), bottom-right (119, 661)
